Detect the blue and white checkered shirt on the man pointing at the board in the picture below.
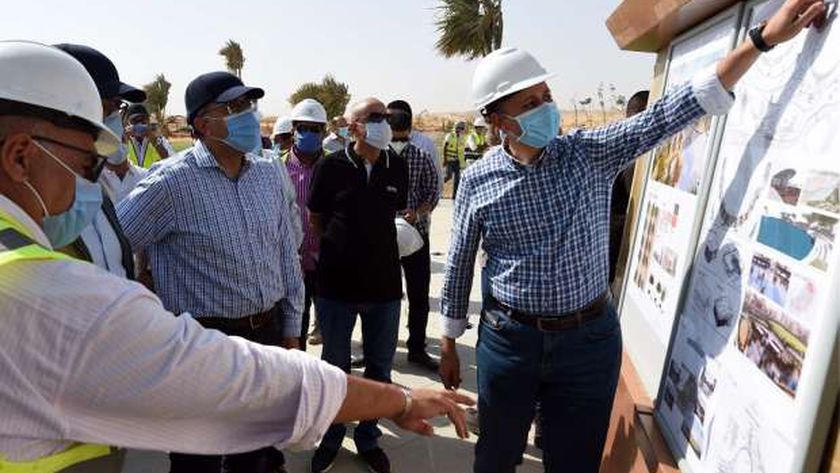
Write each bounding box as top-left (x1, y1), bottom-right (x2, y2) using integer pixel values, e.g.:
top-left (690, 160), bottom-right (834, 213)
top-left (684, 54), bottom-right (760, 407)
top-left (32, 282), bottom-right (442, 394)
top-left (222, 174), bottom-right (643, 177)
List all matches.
top-left (441, 72), bottom-right (733, 338)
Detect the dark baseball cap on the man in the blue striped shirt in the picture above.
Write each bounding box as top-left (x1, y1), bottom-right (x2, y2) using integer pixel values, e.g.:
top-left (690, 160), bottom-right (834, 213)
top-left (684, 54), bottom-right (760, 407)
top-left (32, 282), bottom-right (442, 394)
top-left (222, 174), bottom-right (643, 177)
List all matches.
top-left (184, 71), bottom-right (265, 125)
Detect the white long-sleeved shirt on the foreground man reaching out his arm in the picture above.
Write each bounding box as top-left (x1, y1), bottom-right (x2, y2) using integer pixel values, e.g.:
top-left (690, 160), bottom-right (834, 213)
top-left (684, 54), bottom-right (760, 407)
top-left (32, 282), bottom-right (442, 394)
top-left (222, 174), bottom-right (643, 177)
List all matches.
top-left (0, 195), bottom-right (347, 461)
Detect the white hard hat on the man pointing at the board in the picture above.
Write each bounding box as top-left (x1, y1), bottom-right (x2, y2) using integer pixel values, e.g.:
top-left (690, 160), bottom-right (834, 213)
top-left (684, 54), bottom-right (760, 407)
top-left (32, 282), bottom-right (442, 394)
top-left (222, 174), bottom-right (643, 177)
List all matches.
top-left (472, 48), bottom-right (554, 110)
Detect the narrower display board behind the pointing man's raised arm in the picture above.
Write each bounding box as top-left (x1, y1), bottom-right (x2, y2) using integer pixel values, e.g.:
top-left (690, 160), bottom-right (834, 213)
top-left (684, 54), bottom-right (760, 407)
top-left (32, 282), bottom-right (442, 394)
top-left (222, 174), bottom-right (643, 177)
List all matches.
top-left (620, 7), bottom-right (740, 397)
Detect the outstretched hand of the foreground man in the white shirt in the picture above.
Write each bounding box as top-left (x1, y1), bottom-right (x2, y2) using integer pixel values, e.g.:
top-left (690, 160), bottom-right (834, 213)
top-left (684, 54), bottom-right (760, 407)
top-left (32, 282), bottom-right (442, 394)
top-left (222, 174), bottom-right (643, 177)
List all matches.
top-left (393, 389), bottom-right (475, 439)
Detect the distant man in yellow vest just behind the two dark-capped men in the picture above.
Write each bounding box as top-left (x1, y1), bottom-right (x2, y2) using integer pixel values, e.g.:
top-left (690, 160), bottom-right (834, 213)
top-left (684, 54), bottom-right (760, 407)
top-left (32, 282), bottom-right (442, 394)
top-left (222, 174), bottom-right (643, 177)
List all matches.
top-left (125, 103), bottom-right (175, 169)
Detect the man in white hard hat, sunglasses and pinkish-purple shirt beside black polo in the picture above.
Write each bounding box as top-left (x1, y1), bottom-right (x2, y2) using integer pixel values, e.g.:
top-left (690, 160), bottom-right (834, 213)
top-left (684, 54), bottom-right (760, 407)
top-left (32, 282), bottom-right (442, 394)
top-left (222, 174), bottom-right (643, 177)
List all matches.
top-left (286, 99), bottom-right (327, 350)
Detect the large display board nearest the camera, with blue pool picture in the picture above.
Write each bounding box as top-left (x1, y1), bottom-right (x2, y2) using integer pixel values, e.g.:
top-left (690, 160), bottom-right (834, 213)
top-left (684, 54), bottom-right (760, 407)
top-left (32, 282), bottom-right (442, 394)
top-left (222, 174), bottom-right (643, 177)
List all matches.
top-left (656, 1), bottom-right (840, 473)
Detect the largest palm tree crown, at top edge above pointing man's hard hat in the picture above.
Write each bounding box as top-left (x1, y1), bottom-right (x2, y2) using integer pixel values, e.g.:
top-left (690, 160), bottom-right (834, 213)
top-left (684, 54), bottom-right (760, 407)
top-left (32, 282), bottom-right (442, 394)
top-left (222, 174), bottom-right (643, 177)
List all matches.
top-left (435, 0), bottom-right (504, 59)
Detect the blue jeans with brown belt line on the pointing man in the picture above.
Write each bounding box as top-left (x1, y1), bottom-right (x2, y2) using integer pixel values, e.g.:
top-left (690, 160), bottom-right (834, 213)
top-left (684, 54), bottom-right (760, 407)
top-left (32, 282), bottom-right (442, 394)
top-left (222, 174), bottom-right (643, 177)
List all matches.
top-left (474, 301), bottom-right (621, 473)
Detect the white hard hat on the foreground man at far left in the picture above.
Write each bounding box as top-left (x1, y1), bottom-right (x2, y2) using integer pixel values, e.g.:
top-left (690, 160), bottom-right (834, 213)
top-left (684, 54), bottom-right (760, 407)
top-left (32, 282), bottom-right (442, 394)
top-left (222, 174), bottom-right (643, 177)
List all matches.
top-left (0, 41), bottom-right (120, 156)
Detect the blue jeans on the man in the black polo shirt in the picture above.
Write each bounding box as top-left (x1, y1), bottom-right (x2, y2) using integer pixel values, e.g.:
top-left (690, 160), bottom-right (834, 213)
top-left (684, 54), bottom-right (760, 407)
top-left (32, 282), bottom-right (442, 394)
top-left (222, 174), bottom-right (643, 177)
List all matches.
top-left (315, 297), bottom-right (400, 452)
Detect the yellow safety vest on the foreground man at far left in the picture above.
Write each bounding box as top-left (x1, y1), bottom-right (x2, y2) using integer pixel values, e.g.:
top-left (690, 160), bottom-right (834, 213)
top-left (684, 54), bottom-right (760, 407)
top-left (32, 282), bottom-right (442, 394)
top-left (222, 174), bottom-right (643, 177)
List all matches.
top-left (0, 212), bottom-right (111, 473)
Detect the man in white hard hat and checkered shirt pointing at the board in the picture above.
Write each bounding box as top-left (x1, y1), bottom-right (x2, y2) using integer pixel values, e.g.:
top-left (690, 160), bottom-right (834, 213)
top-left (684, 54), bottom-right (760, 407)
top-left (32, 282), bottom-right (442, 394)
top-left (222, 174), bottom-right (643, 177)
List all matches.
top-left (441, 0), bottom-right (826, 473)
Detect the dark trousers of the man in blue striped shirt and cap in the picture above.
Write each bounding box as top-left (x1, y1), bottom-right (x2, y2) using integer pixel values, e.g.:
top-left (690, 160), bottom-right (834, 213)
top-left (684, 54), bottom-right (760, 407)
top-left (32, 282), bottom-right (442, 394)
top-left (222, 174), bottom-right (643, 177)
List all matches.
top-left (169, 318), bottom-right (286, 473)
